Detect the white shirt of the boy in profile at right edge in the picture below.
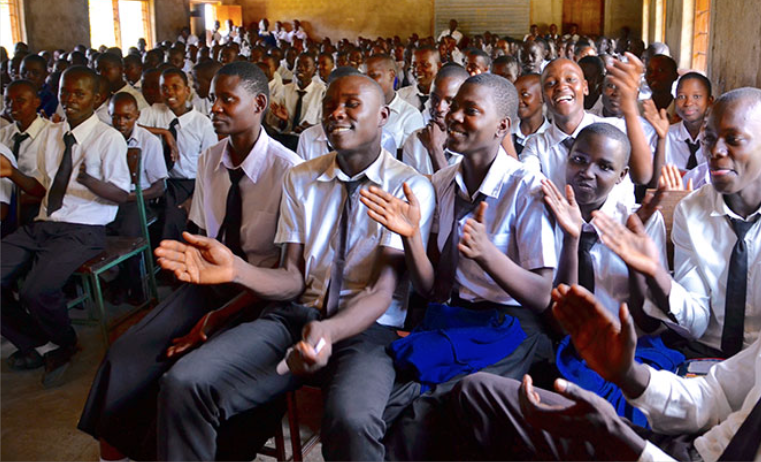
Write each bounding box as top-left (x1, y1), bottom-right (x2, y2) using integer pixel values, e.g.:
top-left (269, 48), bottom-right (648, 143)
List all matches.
top-left (644, 185), bottom-right (761, 350)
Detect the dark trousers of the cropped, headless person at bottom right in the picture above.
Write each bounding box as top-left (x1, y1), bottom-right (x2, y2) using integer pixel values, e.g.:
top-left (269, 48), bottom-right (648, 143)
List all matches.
top-left (449, 373), bottom-right (699, 461)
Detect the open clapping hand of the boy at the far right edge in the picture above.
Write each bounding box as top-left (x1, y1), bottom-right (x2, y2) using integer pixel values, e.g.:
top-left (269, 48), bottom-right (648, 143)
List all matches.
top-left (593, 211), bottom-right (661, 277)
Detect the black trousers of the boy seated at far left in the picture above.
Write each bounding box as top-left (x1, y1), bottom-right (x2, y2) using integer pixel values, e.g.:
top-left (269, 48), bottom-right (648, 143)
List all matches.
top-left (1, 221), bottom-right (106, 350)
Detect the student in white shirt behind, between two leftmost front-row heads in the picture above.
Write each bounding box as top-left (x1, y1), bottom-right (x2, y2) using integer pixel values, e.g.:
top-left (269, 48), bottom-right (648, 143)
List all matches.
top-left (269, 53), bottom-right (325, 134)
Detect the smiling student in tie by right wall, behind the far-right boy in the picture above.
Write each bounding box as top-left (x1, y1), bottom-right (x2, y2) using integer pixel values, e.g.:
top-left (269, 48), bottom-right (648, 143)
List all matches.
top-left (665, 72), bottom-right (713, 171)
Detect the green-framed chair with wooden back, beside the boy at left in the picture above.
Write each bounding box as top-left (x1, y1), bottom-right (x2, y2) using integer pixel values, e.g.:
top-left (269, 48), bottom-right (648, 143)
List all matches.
top-left (69, 148), bottom-right (158, 345)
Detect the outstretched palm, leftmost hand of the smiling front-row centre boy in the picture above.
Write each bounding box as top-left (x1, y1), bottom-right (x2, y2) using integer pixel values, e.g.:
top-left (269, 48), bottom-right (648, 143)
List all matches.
top-left (155, 232), bottom-right (235, 284)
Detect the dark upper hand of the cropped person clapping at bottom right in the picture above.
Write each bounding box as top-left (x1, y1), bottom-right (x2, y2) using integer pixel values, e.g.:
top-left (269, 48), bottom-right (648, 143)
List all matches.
top-left (552, 284), bottom-right (637, 384)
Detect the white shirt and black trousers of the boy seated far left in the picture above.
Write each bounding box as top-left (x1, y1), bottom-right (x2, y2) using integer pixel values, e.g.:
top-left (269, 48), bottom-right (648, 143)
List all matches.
top-left (2, 114), bottom-right (130, 351)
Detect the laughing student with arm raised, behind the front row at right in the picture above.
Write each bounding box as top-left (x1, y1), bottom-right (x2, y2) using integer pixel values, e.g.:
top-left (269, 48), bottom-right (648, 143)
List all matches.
top-left (521, 55), bottom-right (652, 204)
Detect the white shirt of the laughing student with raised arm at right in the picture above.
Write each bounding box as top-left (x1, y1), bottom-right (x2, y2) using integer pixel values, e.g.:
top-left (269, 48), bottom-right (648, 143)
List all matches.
top-left (519, 111), bottom-right (635, 206)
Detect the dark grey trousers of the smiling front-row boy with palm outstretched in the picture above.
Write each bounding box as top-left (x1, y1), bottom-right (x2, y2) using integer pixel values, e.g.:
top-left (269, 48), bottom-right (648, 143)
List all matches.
top-left (158, 303), bottom-right (398, 460)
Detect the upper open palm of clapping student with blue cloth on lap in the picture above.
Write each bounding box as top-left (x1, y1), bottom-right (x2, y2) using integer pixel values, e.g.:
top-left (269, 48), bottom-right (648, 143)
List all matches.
top-left (359, 183), bottom-right (420, 237)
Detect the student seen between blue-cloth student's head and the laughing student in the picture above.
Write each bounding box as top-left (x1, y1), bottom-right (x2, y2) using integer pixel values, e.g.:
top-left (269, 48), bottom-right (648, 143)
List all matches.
top-left (511, 74), bottom-right (550, 155)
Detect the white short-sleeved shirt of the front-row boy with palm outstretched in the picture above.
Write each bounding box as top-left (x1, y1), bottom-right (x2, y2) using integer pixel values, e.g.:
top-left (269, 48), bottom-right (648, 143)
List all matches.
top-left (275, 149), bottom-right (435, 327)
